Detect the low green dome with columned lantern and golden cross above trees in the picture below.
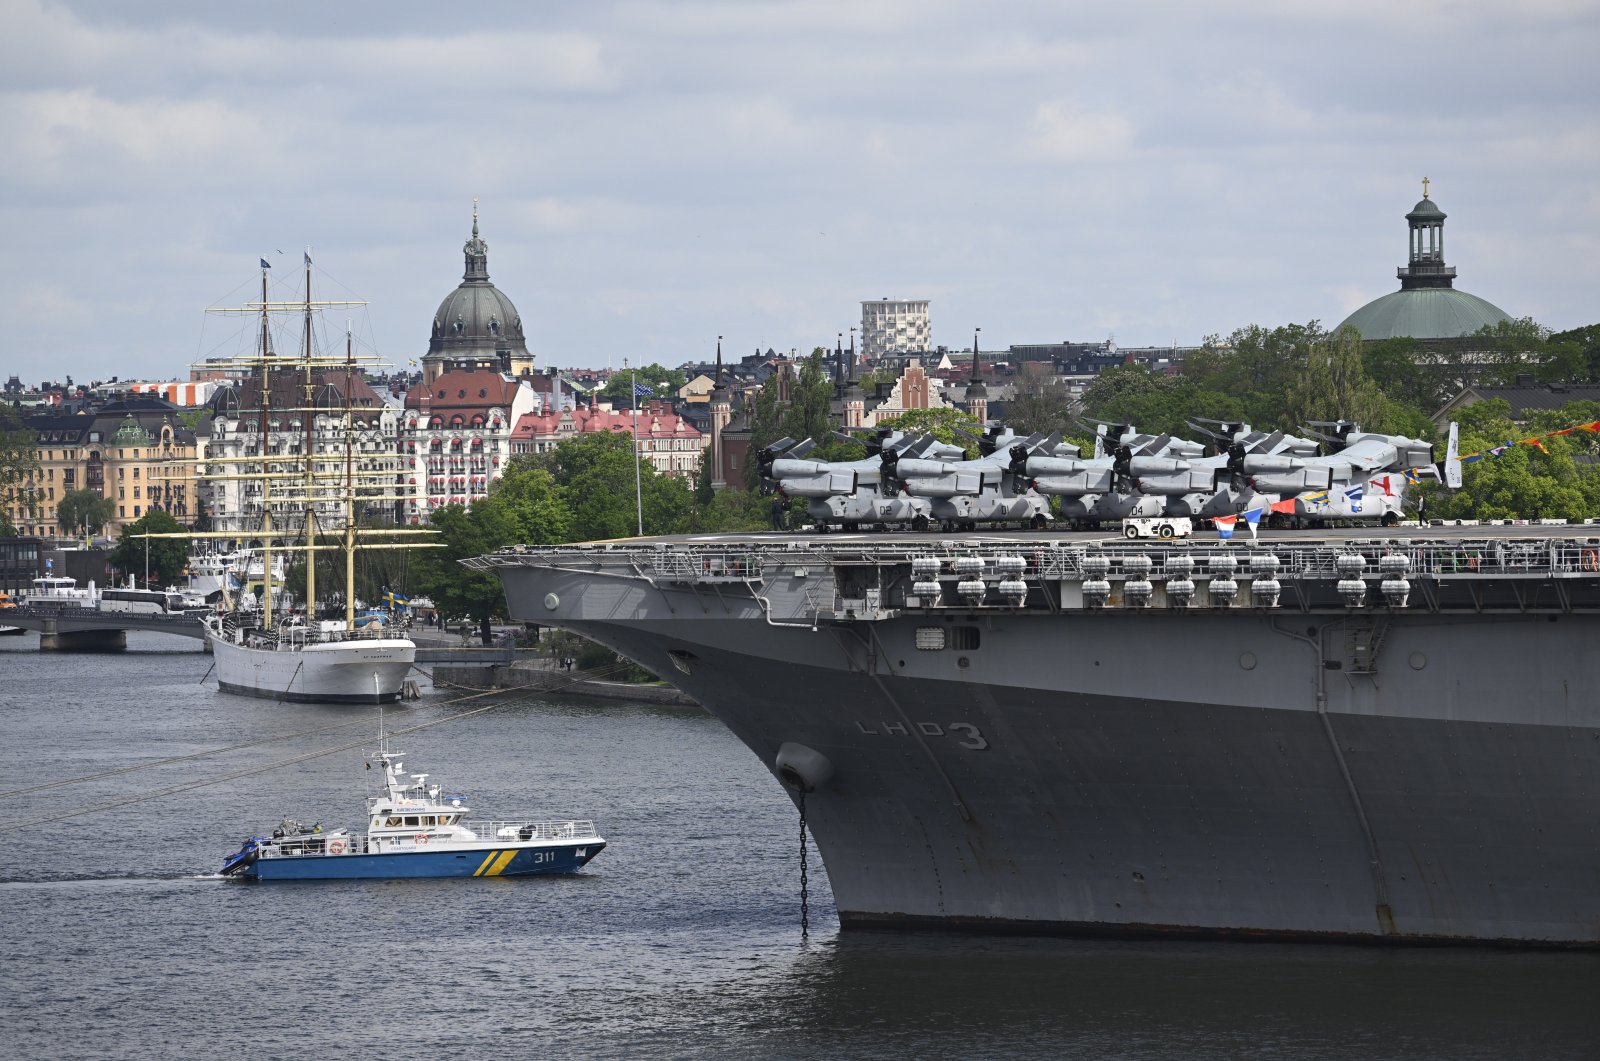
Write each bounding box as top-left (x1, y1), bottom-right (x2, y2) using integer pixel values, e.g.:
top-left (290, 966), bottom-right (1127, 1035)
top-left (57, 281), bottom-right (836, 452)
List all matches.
top-left (1339, 178), bottom-right (1510, 341)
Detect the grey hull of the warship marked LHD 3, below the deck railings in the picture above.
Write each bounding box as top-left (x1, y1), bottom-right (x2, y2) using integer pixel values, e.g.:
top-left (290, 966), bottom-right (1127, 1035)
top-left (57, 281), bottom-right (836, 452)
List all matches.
top-left (501, 568), bottom-right (1600, 946)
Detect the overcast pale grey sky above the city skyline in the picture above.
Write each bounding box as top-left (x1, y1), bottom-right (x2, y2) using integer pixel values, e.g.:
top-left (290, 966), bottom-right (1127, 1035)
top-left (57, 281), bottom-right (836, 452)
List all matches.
top-left (0, 0), bottom-right (1600, 382)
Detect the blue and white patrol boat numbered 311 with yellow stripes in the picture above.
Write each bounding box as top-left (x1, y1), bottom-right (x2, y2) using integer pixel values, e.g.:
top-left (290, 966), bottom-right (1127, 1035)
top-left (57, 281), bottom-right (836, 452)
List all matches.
top-left (222, 746), bottom-right (605, 880)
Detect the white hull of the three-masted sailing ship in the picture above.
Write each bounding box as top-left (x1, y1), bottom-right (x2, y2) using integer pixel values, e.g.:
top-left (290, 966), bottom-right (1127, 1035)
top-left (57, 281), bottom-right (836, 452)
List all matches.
top-left (206, 627), bottom-right (416, 704)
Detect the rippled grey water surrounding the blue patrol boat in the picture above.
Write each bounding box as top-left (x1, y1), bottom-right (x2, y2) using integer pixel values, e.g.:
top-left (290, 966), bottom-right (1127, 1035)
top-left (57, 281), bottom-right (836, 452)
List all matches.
top-left (0, 634), bottom-right (1600, 1059)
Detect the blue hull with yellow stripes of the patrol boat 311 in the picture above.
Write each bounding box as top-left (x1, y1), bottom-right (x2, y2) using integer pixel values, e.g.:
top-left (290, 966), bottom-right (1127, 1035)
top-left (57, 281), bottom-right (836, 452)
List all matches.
top-left (240, 840), bottom-right (605, 880)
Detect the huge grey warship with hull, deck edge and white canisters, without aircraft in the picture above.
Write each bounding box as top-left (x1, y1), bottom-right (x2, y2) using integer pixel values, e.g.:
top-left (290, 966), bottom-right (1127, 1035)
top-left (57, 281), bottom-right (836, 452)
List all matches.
top-left (466, 526), bottom-right (1600, 947)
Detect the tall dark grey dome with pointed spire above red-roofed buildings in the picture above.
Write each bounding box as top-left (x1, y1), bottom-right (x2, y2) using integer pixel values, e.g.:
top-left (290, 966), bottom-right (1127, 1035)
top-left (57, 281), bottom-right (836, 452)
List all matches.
top-left (422, 200), bottom-right (533, 382)
